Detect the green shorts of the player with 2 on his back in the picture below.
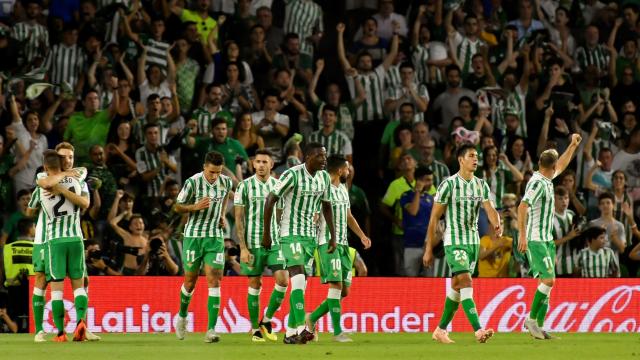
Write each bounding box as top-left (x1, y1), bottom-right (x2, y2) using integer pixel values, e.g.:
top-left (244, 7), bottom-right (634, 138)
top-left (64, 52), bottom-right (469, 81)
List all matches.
top-left (44, 237), bottom-right (85, 281)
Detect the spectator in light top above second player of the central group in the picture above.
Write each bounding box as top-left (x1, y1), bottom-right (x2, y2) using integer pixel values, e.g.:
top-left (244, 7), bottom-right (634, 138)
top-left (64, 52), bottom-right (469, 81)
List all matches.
top-left (251, 91), bottom-right (289, 164)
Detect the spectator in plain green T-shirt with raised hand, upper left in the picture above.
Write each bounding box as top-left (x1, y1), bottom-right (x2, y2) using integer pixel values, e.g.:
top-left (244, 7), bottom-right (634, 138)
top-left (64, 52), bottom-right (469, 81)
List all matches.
top-left (64, 81), bottom-right (119, 165)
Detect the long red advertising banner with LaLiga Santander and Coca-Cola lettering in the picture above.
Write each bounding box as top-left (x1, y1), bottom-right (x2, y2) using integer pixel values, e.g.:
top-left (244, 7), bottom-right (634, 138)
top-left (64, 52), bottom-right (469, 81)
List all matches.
top-left (31, 276), bottom-right (640, 333)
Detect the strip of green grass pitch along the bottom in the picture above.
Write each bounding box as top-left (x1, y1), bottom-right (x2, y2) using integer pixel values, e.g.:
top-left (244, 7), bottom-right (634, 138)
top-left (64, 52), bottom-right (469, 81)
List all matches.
top-left (0, 333), bottom-right (640, 360)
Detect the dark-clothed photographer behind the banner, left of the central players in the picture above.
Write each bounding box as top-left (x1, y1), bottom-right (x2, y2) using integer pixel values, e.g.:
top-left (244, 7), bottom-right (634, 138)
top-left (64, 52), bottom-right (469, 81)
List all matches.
top-left (137, 232), bottom-right (180, 276)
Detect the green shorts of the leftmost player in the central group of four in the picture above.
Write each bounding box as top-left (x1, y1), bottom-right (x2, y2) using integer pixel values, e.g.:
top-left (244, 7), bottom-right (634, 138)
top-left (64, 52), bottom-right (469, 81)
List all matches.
top-left (182, 237), bottom-right (224, 273)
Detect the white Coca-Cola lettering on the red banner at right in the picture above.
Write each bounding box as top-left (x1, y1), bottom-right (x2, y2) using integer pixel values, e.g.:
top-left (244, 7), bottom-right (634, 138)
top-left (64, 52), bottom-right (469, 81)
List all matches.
top-left (480, 285), bottom-right (640, 332)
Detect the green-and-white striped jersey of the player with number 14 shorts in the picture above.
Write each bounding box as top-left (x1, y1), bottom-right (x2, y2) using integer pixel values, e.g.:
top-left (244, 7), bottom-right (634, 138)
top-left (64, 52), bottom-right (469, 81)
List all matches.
top-left (271, 163), bottom-right (331, 238)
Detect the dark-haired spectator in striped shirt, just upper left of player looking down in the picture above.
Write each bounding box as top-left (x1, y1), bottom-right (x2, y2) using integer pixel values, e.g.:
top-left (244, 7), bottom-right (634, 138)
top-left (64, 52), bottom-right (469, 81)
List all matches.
top-left (136, 124), bottom-right (178, 200)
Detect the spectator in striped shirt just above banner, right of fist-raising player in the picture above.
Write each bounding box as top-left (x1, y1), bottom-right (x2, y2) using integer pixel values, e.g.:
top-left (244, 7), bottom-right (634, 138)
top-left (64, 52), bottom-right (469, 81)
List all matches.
top-left (576, 226), bottom-right (620, 278)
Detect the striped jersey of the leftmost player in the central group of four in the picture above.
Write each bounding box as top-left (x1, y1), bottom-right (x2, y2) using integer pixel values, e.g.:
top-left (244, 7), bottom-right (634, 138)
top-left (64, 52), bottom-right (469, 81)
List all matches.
top-left (177, 172), bottom-right (233, 238)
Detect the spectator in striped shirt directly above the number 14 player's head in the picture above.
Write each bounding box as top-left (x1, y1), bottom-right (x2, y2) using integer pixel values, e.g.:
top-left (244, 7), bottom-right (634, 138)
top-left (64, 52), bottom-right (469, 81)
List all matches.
top-left (309, 105), bottom-right (353, 162)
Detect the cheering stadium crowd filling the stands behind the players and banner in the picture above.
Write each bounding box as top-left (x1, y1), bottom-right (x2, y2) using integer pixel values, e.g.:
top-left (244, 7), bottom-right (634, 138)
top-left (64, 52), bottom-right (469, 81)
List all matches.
top-left (0, 0), bottom-right (640, 334)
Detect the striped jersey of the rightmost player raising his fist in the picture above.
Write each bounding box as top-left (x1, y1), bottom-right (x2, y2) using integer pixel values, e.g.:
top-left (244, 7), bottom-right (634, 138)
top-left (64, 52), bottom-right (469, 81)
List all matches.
top-left (522, 171), bottom-right (555, 241)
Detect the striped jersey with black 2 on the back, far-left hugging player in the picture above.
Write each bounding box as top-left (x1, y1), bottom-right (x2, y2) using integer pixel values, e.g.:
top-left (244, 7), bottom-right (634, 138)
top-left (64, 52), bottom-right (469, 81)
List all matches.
top-left (29, 177), bottom-right (88, 241)
